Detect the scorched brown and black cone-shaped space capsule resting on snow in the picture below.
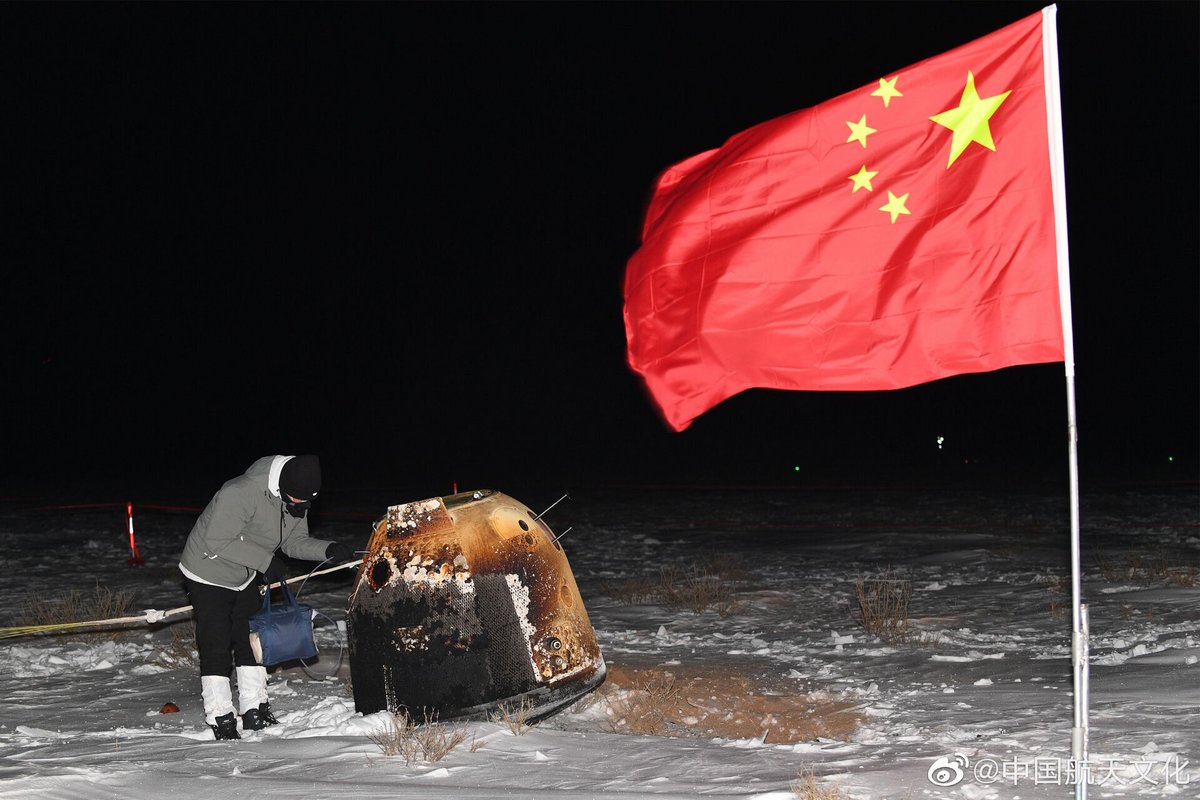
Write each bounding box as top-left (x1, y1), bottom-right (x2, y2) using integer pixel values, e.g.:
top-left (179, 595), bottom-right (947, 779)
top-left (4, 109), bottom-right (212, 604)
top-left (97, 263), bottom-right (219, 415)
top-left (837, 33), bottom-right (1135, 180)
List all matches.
top-left (347, 489), bottom-right (605, 720)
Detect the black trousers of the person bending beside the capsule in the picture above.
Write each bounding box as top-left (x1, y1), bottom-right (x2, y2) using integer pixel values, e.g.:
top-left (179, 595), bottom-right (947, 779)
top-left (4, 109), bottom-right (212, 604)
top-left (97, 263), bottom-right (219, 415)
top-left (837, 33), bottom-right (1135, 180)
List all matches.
top-left (184, 578), bottom-right (263, 678)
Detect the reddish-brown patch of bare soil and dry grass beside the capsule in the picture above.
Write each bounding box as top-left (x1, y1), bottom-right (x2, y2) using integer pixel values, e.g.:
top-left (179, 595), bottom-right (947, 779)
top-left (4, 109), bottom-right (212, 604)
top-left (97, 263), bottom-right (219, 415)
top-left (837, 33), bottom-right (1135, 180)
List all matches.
top-left (594, 664), bottom-right (862, 744)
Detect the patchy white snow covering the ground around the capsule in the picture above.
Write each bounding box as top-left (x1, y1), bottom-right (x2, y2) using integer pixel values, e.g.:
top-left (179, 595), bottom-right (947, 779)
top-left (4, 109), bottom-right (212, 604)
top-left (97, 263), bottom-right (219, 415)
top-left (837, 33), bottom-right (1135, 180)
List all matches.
top-left (0, 485), bottom-right (1200, 800)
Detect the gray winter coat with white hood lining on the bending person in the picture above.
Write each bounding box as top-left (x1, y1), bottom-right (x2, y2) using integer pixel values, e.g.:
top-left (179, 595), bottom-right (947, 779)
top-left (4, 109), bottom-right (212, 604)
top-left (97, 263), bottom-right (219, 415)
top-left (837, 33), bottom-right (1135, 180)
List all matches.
top-left (179, 456), bottom-right (329, 589)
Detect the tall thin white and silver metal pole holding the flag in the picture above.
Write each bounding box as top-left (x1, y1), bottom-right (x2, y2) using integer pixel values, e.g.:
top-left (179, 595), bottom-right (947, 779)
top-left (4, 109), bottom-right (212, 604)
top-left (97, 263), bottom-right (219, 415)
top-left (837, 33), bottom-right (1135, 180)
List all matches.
top-left (1042, 6), bottom-right (1088, 800)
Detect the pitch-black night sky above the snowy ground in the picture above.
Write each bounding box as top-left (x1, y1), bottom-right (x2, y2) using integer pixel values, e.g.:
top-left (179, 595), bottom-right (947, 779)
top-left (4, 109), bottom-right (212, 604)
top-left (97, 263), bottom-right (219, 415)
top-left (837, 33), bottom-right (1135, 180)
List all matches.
top-left (0, 0), bottom-right (1200, 503)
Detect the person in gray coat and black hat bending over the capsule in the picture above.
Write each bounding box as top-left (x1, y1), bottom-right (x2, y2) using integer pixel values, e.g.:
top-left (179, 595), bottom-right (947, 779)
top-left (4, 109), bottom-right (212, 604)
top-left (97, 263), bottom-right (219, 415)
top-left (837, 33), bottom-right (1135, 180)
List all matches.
top-left (179, 456), bottom-right (354, 739)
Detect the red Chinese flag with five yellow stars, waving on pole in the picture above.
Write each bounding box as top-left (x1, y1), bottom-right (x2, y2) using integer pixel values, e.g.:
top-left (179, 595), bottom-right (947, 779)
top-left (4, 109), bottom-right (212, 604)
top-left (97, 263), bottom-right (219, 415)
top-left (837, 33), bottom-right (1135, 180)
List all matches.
top-left (625, 12), bottom-right (1064, 431)
